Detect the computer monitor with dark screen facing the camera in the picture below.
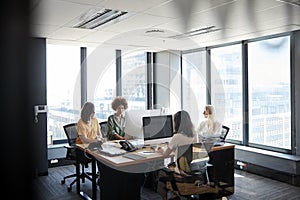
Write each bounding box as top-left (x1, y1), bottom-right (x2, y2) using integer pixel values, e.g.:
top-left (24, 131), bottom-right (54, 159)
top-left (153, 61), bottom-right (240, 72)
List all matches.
top-left (143, 115), bottom-right (173, 145)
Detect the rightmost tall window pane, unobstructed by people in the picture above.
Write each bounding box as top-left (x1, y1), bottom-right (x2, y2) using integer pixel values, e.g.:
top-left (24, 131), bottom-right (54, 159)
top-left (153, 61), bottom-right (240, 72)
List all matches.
top-left (248, 36), bottom-right (291, 150)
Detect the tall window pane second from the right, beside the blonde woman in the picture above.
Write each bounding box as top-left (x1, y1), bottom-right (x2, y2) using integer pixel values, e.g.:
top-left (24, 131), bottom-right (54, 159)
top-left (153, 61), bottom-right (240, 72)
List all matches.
top-left (211, 44), bottom-right (243, 141)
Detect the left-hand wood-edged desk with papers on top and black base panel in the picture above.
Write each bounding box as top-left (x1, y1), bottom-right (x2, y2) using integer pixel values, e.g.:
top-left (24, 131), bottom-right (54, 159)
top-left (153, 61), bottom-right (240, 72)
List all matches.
top-left (76, 144), bottom-right (173, 200)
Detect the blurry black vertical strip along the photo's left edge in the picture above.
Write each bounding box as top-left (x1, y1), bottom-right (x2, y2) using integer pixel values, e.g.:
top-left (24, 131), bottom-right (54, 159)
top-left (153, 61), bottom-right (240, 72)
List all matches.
top-left (0, 0), bottom-right (33, 199)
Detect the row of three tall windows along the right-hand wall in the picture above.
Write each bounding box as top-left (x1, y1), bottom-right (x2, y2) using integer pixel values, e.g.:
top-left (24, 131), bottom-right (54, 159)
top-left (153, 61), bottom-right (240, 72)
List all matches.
top-left (182, 35), bottom-right (292, 152)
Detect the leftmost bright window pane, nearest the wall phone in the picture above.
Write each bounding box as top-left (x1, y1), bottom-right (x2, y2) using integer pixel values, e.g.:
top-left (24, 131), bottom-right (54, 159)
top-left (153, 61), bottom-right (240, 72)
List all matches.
top-left (47, 44), bottom-right (81, 144)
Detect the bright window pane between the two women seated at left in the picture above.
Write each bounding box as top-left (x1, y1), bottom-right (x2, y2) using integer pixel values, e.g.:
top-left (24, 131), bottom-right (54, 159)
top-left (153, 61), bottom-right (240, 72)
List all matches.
top-left (87, 47), bottom-right (116, 121)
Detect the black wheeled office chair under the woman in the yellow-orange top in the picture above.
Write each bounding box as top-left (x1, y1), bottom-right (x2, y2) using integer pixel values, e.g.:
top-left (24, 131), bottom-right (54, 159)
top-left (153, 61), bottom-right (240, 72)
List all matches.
top-left (61, 123), bottom-right (92, 192)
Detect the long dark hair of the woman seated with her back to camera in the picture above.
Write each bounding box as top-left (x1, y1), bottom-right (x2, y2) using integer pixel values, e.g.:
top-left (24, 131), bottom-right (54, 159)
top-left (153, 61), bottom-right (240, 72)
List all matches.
top-left (174, 110), bottom-right (194, 137)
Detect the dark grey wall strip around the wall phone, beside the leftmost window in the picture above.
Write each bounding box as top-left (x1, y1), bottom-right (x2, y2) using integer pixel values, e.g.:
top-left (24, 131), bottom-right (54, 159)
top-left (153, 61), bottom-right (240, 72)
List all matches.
top-left (27, 38), bottom-right (48, 176)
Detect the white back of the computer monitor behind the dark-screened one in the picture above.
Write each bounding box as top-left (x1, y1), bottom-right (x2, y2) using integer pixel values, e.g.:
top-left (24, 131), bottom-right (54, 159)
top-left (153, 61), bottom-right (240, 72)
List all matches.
top-left (124, 109), bottom-right (161, 139)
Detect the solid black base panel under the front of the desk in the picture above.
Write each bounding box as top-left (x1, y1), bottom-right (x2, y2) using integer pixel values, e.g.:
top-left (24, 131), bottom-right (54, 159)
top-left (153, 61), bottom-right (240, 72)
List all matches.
top-left (100, 164), bottom-right (143, 200)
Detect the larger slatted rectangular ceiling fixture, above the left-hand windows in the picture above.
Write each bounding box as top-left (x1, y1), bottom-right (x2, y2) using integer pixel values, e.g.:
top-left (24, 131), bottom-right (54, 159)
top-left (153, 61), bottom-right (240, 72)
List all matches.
top-left (73, 9), bottom-right (127, 29)
